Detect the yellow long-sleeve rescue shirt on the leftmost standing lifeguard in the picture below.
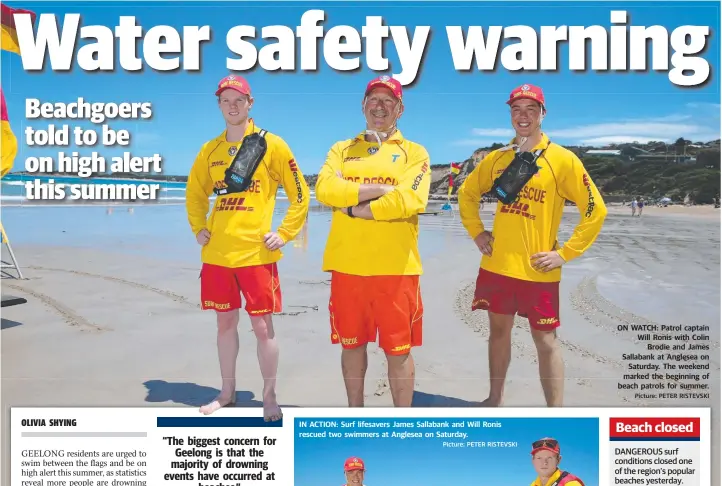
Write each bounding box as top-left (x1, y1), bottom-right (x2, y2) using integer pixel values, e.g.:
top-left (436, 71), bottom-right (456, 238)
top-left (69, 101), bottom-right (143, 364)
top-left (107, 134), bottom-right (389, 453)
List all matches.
top-left (186, 119), bottom-right (310, 268)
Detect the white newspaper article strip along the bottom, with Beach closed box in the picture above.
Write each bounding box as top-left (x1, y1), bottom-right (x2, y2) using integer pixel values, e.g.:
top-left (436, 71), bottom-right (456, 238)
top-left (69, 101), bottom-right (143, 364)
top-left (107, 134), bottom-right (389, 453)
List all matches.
top-left (11, 407), bottom-right (712, 486)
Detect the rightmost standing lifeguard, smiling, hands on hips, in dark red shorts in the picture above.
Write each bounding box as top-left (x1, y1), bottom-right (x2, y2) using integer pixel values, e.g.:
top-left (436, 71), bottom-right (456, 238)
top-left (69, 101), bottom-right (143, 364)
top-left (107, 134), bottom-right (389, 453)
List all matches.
top-left (459, 84), bottom-right (607, 406)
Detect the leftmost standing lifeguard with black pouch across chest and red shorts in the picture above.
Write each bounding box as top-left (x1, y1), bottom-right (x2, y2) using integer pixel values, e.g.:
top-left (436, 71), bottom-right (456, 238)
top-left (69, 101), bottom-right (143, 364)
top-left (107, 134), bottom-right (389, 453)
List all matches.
top-left (186, 75), bottom-right (310, 421)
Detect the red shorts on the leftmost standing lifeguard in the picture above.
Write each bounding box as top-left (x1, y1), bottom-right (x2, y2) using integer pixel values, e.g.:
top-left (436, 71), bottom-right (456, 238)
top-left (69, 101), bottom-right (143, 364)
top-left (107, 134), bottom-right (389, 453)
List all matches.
top-left (201, 263), bottom-right (282, 316)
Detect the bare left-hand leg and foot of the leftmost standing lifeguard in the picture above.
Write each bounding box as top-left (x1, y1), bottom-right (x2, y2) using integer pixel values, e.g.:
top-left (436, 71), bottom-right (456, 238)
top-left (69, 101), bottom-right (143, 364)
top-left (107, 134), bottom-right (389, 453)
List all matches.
top-left (200, 309), bottom-right (238, 415)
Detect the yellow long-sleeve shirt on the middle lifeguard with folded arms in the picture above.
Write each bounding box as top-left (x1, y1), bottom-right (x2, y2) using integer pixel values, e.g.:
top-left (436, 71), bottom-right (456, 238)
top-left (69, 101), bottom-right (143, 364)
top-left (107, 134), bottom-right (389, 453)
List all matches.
top-left (316, 130), bottom-right (431, 276)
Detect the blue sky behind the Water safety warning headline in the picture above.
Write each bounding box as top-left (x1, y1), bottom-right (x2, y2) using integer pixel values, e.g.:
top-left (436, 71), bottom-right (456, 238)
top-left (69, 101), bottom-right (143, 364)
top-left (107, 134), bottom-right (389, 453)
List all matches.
top-left (2, 1), bottom-right (720, 174)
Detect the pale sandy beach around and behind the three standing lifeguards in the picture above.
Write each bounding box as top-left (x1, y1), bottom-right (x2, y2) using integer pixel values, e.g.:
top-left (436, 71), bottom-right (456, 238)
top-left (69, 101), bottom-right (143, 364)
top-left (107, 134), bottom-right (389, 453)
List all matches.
top-left (2, 201), bottom-right (720, 483)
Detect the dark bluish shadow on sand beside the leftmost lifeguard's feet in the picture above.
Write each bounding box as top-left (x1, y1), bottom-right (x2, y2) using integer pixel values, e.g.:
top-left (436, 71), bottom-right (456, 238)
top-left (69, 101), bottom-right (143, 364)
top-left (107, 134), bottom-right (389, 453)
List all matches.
top-left (143, 380), bottom-right (296, 408)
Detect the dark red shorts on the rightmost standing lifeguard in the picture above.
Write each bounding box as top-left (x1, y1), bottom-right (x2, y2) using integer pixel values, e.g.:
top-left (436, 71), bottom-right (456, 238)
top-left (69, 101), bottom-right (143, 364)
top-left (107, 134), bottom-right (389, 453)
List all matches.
top-left (471, 268), bottom-right (561, 331)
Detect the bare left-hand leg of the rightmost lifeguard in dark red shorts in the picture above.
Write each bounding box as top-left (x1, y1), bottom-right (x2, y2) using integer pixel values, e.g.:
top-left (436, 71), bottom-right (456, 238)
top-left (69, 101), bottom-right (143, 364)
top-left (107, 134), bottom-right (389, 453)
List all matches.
top-left (481, 311), bottom-right (514, 407)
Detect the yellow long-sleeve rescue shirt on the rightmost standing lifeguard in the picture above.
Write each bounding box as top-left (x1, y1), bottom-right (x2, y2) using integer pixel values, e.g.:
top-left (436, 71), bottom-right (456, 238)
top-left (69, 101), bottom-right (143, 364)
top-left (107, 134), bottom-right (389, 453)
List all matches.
top-left (459, 135), bottom-right (607, 282)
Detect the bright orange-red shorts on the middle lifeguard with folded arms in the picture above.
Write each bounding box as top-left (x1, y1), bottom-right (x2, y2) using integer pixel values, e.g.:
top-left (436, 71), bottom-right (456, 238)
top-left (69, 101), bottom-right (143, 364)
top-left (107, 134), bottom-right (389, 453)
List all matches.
top-left (328, 272), bottom-right (424, 355)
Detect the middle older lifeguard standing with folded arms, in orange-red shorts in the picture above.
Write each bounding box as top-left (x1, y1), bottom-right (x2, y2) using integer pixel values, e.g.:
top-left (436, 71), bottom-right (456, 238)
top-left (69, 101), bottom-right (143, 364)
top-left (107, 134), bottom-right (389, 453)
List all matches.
top-left (316, 76), bottom-right (431, 407)
